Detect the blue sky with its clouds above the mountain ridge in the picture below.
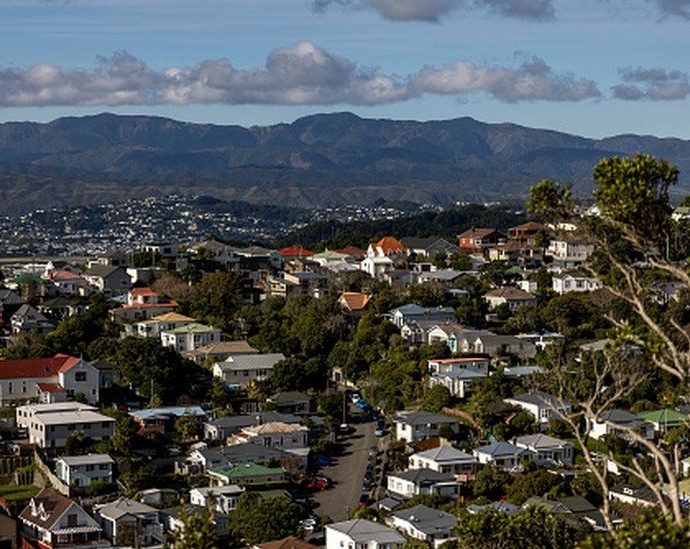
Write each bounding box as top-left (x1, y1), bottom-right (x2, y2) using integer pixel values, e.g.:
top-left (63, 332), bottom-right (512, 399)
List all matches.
top-left (0, 0), bottom-right (690, 138)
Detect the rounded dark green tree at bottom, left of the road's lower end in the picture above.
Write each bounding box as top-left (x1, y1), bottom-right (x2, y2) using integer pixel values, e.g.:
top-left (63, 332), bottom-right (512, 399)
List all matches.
top-left (230, 492), bottom-right (302, 544)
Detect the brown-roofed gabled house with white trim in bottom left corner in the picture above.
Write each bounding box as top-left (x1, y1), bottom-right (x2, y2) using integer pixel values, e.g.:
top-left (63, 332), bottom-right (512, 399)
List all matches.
top-left (19, 488), bottom-right (105, 549)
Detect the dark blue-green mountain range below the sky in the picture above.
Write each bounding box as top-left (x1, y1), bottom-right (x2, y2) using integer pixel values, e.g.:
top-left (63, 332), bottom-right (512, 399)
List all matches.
top-left (0, 113), bottom-right (690, 214)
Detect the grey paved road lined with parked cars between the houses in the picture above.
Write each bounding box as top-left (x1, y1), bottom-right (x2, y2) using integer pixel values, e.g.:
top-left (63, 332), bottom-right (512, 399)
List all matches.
top-left (314, 421), bottom-right (377, 521)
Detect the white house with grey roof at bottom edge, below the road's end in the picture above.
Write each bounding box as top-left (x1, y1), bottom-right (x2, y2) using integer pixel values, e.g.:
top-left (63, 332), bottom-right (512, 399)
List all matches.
top-left (326, 519), bottom-right (407, 549)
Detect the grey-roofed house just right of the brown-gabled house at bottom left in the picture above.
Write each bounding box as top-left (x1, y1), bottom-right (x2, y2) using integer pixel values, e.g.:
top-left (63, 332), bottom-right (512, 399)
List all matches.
top-left (94, 497), bottom-right (165, 547)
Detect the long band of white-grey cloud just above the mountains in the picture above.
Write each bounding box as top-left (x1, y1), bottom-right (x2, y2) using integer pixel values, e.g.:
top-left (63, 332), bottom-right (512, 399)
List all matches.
top-left (0, 42), bottom-right (600, 107)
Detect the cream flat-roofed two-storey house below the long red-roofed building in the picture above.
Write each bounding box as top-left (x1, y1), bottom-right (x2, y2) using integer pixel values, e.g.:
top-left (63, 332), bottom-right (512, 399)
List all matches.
top-left (23, 403), bottom-right (115, 448)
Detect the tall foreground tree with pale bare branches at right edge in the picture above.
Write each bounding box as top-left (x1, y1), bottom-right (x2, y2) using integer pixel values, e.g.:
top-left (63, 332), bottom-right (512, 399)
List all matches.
top-left (529, 155), bottom-right (690, 532)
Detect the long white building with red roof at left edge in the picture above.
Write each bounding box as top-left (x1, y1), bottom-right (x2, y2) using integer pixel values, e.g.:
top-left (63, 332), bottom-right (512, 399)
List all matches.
top-left (0, 354), bottom-right (100, 406)
